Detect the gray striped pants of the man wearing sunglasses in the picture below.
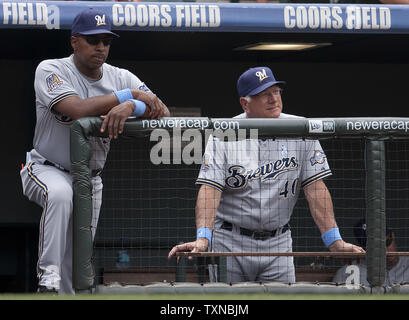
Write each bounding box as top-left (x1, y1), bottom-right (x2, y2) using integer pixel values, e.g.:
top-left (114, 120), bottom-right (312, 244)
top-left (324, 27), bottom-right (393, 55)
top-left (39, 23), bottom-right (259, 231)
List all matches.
top-left (20, 151), bottom-right (103, 294)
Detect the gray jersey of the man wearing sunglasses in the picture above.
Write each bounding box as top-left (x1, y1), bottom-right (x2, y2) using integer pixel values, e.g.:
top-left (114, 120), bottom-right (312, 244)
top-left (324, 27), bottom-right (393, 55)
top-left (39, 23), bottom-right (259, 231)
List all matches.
top-left (33, 55), bottom-right (150, 170)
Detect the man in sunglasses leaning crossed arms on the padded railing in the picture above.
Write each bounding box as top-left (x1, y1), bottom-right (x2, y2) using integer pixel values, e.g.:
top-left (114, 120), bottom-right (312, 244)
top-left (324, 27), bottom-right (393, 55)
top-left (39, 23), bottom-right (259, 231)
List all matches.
top-left (20, 9), bottom-right (169, 293)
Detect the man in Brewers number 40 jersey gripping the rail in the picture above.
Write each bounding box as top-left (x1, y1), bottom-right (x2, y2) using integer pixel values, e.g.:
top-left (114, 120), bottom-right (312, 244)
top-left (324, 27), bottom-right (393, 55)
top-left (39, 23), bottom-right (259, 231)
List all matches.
top-left (168, 67), bottom-right (364, 283)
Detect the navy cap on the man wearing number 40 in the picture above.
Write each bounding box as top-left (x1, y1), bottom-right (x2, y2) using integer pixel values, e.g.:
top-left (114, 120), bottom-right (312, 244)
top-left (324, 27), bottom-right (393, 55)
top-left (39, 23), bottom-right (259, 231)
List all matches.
top-left (237, 67), bottom-right (285, 97)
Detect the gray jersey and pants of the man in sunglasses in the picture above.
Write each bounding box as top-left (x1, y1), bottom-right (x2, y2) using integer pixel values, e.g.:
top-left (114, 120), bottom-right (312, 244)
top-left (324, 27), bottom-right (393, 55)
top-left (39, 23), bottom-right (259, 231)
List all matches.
top-left (20, 55), bottom-right (150, 293)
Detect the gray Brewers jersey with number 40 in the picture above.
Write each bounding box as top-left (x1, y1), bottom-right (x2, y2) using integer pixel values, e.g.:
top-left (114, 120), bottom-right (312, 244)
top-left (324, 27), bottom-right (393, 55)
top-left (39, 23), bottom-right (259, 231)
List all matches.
top-left (196, 114), bottom-right (331, 230)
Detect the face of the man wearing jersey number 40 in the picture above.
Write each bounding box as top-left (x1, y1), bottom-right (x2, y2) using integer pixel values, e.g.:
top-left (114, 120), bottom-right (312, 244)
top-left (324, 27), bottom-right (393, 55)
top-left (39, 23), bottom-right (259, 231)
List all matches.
top-left (240, 85), bottom-right (283, 118)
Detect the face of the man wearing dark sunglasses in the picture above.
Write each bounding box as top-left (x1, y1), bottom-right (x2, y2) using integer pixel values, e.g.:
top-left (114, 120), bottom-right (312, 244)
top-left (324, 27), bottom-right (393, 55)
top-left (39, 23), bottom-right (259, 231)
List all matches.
top-left (71, 34), bottom-right (113, 70)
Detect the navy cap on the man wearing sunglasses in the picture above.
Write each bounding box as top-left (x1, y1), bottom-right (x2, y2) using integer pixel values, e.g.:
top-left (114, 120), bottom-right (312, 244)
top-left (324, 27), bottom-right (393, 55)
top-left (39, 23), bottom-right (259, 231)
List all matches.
top-left (71, 8), bottom-right (119, 37)
